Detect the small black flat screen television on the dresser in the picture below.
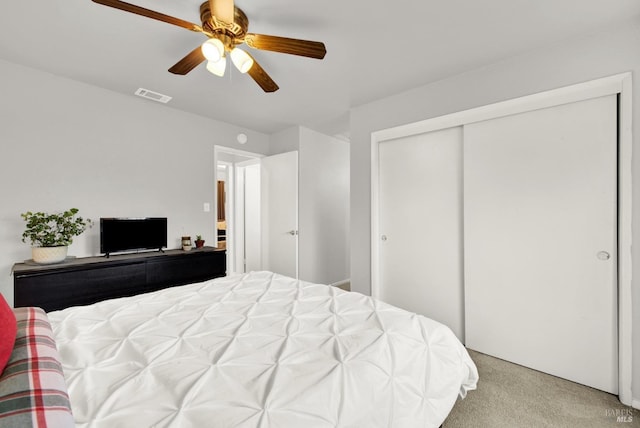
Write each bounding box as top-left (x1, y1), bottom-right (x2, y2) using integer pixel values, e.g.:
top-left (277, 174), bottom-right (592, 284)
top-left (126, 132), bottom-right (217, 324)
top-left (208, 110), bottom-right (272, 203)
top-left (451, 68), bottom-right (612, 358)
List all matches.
top-left (100, 217), bottom-right (167, 257)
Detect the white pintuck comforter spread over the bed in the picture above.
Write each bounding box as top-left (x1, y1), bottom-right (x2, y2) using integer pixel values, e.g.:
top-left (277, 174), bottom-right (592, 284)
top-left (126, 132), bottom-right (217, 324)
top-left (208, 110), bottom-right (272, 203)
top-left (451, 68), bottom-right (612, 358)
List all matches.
top-left (49, 272), bottom-right (478, 428)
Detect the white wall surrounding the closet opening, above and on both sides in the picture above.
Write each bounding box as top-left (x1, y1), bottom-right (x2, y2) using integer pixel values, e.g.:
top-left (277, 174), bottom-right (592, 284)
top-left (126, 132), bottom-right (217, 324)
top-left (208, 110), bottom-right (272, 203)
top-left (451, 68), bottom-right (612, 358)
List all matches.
top-left (351, 25), bottom-right (640, 404)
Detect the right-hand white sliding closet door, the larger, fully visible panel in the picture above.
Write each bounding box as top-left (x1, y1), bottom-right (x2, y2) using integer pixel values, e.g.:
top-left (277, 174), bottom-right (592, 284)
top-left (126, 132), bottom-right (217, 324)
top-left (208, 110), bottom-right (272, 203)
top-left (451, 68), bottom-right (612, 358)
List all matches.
top-left (464, 96), bottom-right (618, 393)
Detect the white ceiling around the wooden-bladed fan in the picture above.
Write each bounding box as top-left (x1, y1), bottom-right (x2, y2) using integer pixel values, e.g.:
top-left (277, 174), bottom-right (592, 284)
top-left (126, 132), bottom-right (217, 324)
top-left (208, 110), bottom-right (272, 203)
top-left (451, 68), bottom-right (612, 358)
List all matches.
top-left (0, 0), bottom-right (640, 134)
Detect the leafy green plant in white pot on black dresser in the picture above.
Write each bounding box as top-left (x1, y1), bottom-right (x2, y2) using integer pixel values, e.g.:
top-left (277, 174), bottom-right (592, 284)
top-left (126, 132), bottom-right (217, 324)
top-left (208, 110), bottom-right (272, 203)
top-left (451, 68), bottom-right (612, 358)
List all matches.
top-left (20, 208), bottom-right (92, 264)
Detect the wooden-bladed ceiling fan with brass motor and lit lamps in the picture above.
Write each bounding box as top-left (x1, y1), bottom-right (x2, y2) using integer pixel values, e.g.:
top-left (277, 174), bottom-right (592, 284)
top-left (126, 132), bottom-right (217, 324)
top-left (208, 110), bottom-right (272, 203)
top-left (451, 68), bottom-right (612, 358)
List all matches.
top-left (92, 0), bottom-right (327, 92)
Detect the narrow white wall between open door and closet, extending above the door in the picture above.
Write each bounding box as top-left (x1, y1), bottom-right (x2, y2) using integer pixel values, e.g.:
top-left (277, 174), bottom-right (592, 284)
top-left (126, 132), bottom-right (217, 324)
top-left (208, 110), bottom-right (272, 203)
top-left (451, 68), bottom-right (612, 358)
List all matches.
top-left (270, 126), bottom-right (350, 284)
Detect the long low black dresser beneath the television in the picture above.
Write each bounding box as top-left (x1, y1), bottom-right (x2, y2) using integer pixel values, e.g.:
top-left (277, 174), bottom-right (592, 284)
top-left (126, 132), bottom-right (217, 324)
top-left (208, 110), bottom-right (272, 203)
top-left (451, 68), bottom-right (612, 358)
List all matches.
top-left (13, 247), bottom-right (227, 312)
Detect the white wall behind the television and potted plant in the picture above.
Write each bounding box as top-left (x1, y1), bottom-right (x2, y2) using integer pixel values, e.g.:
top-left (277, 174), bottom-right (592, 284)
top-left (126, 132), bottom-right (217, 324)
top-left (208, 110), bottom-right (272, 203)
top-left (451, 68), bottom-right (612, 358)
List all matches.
top-left (0, 61), bottom-right (269, 303)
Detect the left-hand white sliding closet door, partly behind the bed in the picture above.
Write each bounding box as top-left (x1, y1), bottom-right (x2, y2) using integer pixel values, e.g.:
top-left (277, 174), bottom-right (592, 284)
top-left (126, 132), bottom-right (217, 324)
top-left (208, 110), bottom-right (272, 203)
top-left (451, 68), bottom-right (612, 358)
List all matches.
top-left (377, 127), bottom-right (464, 340)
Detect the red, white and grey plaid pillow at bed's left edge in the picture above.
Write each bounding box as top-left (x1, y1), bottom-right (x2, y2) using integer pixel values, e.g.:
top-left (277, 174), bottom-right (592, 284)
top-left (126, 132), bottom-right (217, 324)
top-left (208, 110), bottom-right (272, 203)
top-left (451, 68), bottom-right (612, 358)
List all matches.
top-left (0, 308), bottom-right (75, 428)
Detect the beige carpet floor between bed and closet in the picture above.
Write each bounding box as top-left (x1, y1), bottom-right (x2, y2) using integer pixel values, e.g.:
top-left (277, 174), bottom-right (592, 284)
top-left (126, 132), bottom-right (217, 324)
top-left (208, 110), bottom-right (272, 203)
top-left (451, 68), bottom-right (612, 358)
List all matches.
top-left (444, 350), bottom-right (640, 428)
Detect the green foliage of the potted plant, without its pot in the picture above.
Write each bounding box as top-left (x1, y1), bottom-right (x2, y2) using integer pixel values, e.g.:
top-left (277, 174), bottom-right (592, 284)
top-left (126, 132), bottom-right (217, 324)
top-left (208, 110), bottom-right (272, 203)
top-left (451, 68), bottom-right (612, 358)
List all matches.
top-left (20, 208), bottom-right (93, 247)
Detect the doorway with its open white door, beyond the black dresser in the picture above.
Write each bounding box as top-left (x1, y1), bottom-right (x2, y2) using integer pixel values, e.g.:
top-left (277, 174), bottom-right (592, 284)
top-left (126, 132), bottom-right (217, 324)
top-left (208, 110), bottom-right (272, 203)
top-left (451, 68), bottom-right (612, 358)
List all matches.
top-left (215, 146), bottom-right (298, 278)
